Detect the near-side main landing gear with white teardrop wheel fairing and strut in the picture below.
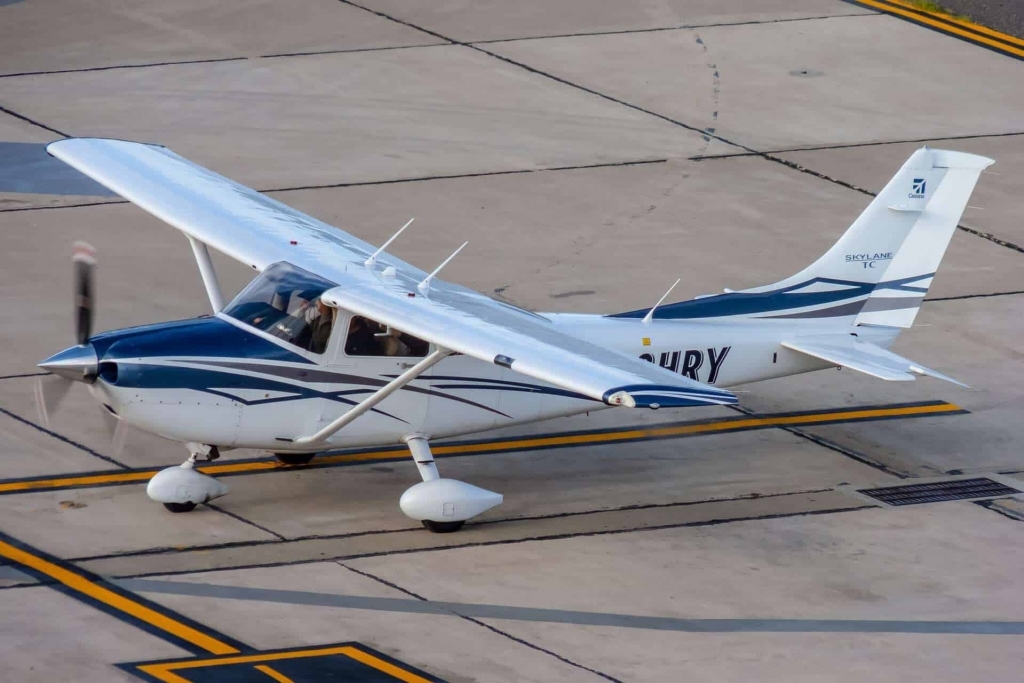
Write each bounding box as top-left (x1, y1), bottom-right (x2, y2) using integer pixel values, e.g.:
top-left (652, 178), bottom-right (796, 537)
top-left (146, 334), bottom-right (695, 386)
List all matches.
top-left (398, 434), bottom-right (504, 533)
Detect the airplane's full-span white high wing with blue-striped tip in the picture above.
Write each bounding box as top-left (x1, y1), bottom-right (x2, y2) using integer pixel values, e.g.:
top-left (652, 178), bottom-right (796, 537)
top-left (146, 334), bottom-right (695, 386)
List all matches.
top-left (47, 138), bottom-right (736, 408)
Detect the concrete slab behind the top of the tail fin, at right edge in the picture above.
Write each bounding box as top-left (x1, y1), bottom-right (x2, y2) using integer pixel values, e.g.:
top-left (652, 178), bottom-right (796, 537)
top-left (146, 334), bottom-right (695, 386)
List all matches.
top-left (780, 134), bottom-right (1024, 248)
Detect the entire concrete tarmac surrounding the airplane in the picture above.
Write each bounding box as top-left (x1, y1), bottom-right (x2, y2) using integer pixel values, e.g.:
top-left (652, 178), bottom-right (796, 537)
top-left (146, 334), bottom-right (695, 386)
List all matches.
top-left (0, 0), bottom-right (1024, 683)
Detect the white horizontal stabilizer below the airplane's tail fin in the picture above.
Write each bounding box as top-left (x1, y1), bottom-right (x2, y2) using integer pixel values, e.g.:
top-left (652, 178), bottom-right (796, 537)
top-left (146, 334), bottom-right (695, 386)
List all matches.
top-left (782, 335), bottom-right (967, 387)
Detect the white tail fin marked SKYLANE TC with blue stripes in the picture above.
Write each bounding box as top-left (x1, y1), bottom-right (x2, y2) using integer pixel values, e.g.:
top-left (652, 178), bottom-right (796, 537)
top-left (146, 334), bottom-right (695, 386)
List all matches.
top-left (606, 147), bottom-right (993, 328)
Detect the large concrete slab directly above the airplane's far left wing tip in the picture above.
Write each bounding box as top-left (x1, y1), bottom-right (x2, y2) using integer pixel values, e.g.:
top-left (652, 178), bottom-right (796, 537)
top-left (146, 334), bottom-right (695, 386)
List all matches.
top-left (4, 46), bottom-right (710, 189)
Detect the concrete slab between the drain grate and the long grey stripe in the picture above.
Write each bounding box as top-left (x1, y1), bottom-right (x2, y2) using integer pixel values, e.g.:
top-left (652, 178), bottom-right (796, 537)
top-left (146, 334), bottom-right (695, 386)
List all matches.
top-left (347, 503), bottom-right (1024, 621)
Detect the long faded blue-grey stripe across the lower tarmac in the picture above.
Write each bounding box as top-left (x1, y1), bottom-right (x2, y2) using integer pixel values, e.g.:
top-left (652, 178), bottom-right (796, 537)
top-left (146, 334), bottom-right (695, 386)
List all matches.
top-left (114, 579), bottom-right (1024, 635)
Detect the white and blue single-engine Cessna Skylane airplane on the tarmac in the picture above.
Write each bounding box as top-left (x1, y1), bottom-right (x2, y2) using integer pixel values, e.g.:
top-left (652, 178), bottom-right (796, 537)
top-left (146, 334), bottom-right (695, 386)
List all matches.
top-left (38, 138), bottom-right (992, 532)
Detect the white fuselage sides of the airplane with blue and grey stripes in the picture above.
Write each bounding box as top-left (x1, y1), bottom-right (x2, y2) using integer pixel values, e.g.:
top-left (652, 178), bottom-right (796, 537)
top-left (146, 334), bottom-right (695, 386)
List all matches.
top-left (92, 313), bottom-right (895, 452)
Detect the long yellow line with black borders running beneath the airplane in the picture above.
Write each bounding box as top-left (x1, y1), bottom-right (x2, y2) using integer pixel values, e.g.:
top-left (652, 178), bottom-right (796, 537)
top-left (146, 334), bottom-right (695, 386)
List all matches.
top-left (0, 403), bottom-right (963, 494)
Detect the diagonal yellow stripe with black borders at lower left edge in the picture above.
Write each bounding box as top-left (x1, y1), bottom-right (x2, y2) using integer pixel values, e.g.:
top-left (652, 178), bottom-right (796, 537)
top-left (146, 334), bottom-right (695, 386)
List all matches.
top-left (0, 541), bottom-right (239, 654)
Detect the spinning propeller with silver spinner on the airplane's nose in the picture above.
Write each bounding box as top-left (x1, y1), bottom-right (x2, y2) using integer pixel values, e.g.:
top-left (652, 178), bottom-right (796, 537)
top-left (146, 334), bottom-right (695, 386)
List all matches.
top-left (36, 242), bottom-right (125, 457)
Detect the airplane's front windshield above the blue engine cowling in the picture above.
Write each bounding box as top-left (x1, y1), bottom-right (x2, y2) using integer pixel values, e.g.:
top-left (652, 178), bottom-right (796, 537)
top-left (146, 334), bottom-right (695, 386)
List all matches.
top-left (224, 263), bottom-right (335, 353)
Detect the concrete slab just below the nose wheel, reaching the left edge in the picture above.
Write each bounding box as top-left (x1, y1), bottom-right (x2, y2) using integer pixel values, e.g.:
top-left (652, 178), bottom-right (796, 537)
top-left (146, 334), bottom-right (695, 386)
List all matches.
top-left (0, 484), bottom-right (273, 557)
